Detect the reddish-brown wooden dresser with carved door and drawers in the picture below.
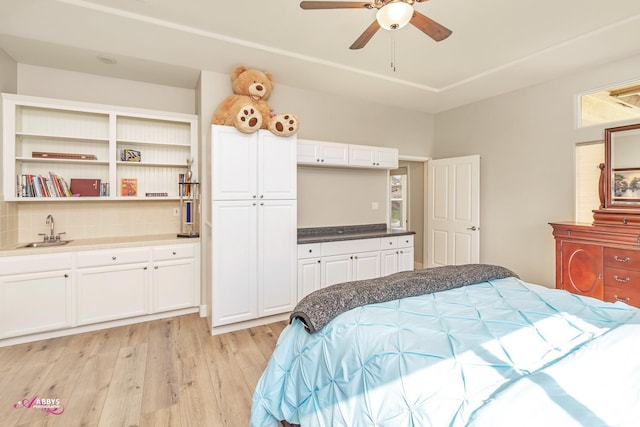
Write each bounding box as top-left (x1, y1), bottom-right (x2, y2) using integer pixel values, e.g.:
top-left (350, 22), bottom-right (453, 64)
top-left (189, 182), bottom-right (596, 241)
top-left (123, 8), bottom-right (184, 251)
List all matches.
top-left (550, 222), bottom-right (640, 307)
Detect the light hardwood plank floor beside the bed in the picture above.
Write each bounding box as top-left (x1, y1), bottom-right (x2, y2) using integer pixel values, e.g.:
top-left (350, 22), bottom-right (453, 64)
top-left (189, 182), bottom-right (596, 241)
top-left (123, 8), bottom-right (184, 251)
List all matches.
top-left (0, 314), bottom-right (286, 427)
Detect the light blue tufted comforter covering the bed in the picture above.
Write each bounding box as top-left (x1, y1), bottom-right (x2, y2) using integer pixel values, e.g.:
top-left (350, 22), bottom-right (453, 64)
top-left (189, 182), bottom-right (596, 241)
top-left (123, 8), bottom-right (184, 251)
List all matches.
top-left (251, 277), bottom-right (640, 427)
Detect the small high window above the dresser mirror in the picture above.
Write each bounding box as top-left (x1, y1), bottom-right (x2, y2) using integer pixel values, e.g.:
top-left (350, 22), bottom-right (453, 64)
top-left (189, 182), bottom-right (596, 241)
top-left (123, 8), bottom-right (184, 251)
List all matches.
top-left (580, 83), bottom-right (640, 127)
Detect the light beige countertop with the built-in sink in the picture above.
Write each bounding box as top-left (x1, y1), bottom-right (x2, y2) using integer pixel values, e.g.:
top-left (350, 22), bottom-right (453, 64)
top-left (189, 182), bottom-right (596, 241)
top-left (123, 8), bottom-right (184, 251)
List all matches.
top-left (0, 234), bottom-right (200, 257)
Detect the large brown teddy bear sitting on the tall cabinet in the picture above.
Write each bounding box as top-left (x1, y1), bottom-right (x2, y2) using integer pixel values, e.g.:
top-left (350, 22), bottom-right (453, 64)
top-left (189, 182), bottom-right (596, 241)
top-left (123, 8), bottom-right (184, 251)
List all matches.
top-left (211, 65), bottom-right (299, 136)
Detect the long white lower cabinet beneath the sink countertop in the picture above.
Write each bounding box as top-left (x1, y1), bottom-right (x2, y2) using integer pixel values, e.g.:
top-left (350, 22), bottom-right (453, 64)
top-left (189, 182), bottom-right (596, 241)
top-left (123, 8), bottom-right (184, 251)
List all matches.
top-left (0, 243), bottom-right (200, 346)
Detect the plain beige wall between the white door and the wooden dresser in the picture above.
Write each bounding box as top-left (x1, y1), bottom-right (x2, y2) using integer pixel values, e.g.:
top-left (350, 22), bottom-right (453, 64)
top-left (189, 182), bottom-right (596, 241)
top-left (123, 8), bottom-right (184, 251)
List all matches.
top-left (434, 51), bottom-right (640, 286)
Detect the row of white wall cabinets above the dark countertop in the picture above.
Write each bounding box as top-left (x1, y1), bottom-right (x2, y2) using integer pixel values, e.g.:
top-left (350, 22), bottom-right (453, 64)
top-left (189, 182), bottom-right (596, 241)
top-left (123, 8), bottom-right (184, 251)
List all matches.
top-left (298, 139), bottom-right (398, 169)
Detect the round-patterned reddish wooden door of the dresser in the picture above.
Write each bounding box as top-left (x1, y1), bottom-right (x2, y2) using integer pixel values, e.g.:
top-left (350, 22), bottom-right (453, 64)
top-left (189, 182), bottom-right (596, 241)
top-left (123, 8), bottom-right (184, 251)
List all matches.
top-left (562, 241), bottom-right (604, 299)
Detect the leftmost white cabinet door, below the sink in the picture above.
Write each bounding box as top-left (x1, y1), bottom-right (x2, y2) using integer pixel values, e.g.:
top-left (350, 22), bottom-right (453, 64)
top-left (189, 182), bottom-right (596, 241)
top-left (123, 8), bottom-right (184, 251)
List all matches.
top-left (0, 270), bottom-right (72, 338)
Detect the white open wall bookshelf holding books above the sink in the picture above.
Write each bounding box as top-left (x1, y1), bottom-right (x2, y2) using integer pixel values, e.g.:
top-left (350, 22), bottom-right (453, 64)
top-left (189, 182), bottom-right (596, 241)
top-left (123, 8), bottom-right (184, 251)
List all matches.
top-left (2, 94), bottom-right (198, 201)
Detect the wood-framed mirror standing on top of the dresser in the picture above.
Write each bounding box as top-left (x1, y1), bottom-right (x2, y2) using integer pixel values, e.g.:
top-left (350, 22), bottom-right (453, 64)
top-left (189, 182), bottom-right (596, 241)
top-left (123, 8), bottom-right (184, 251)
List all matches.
top-left (603, 123), bottom-right (640, 209)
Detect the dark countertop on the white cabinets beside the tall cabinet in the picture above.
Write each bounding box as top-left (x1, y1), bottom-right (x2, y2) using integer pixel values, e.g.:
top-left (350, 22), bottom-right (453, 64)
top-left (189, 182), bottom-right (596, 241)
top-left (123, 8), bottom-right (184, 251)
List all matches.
top-left (298, 224), bottom-right (416, 244)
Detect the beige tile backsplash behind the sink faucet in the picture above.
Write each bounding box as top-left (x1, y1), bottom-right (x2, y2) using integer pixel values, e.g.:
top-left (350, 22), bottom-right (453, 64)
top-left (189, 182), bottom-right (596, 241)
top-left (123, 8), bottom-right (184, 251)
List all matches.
top-left (12, 200), bottom-right (180, 246)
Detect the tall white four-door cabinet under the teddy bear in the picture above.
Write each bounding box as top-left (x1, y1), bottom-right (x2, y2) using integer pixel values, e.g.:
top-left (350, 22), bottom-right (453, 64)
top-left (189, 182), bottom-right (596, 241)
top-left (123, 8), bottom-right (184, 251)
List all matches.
top-left (211, 125), bottom-right (297, 333)
